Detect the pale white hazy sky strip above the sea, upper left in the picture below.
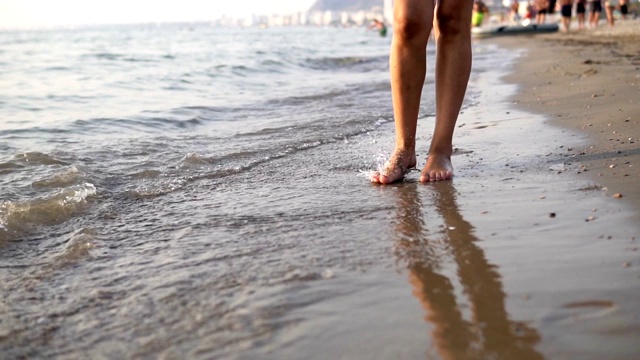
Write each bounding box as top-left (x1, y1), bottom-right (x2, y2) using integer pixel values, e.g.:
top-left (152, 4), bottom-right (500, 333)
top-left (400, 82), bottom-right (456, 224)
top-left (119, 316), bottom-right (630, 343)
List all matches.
top-left (0, 0), bottom-right (314, 28)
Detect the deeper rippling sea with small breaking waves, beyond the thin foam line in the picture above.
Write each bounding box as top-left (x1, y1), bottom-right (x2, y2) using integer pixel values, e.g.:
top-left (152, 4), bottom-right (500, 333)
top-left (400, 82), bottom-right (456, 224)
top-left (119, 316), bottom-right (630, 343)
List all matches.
top-left (0, 25), bottom-right (404, 241)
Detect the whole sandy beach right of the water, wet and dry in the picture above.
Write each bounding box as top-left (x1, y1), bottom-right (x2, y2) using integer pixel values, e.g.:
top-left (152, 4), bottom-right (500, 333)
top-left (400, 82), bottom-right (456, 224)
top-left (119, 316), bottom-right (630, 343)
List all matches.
top-left (272, 23), bottom-right (640, 359)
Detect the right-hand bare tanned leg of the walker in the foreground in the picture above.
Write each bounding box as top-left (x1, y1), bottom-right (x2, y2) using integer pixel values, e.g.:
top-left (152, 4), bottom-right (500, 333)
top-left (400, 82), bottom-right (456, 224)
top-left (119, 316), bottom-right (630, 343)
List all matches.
top-left (420, 0), bottom-right (472, 182)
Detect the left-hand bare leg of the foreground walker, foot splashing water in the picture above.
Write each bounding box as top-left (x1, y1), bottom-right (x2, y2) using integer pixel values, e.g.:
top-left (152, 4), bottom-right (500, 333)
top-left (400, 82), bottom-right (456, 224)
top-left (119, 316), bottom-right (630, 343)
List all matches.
top-left (371, 0), bottom-right (436, 184)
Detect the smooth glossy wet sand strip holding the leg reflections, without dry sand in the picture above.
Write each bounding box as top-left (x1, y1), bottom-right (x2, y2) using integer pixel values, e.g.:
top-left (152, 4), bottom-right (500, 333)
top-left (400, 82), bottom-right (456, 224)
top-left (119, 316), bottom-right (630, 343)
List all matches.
top-left (274, 45), bottom-right (640, 360)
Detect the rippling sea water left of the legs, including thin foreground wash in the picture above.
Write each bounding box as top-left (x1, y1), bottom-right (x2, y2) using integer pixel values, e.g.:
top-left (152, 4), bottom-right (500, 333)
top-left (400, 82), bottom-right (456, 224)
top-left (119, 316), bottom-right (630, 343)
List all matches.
top-left (0, 24), bottom-right (528, 358)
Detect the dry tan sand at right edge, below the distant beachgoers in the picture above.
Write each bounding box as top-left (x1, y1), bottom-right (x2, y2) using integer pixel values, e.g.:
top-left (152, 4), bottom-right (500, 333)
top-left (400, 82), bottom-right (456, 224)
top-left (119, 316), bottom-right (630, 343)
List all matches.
top-left (495, 20), bottom-right (640, 219)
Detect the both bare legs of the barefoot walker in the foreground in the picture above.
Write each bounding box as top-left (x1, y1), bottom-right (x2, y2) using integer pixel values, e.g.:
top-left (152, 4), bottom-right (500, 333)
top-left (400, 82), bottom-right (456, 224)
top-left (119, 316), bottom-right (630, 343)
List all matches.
top-left (370, 0), bottom-right (473, 184)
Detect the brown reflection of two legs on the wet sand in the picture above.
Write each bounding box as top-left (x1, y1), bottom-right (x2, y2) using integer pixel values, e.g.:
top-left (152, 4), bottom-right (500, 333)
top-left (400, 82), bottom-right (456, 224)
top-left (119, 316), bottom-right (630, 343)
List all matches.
top-left (396, 183), bottom-right (542, 359)
